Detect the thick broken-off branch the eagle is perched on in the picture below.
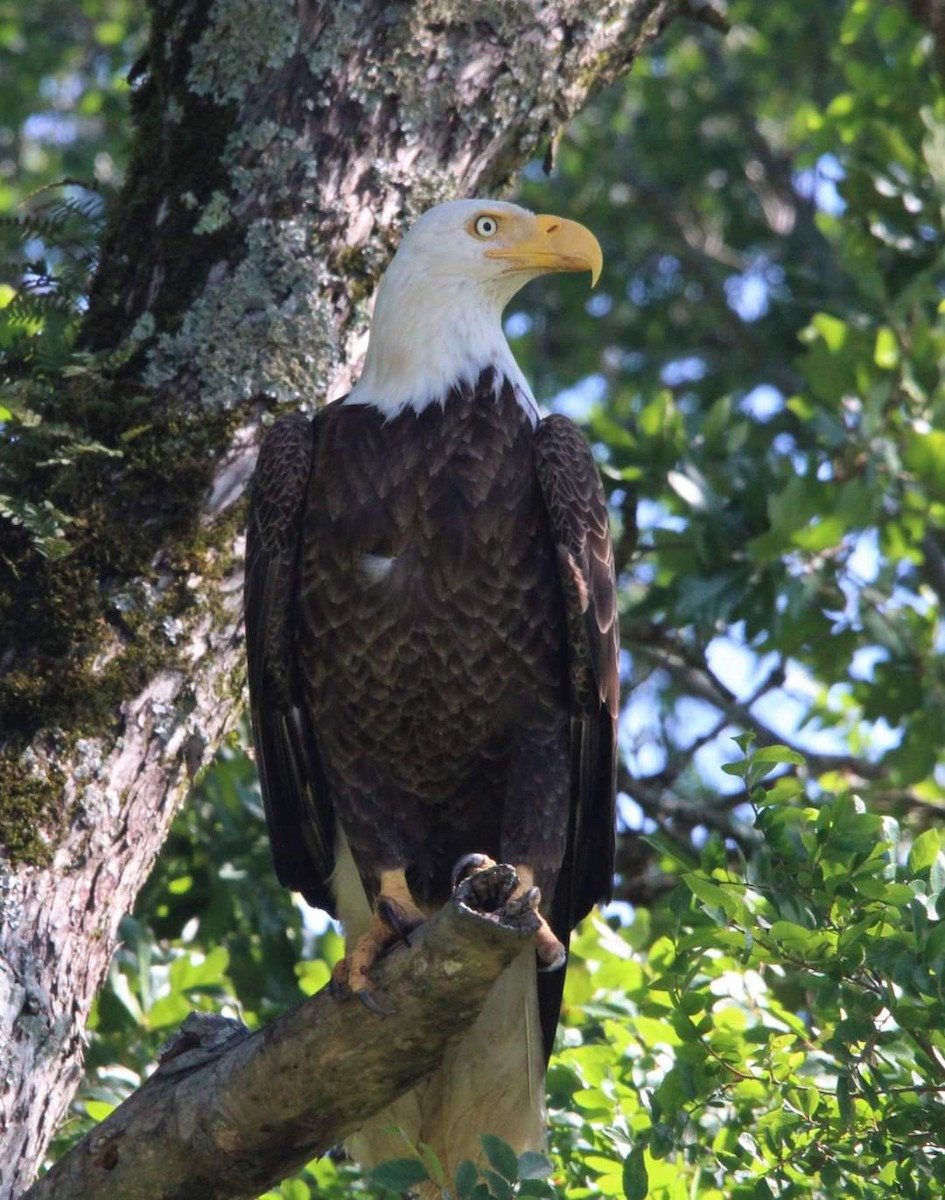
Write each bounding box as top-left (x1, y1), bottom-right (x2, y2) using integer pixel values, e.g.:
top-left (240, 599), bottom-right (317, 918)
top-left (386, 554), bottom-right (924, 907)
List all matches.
top-left (28, 866), bottom-right (538, 1200)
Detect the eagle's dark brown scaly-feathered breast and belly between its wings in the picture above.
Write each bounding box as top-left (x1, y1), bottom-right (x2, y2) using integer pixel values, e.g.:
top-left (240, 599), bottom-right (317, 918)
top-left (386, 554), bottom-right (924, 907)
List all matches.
top-left (299, 374), bottom-right (570, 904)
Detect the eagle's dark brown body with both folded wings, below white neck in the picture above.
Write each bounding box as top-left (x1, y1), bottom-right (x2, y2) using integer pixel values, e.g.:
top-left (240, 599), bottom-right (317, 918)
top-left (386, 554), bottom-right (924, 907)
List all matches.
top-left (246, 370), bottom-right (618, 1046)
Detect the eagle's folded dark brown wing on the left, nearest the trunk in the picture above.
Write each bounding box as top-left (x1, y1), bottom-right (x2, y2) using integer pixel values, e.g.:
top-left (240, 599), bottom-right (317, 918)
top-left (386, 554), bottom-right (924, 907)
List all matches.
top-left (243, 413), bottom-right (335, 912)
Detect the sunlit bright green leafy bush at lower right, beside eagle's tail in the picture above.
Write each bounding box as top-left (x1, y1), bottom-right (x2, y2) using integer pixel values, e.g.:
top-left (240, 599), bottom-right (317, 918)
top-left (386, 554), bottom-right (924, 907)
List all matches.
top-left (550, 738), bottom-right (945, 1200)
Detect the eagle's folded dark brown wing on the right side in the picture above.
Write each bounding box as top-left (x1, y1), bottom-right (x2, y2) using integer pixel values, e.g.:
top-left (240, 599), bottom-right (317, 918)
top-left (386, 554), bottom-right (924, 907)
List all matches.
top-left (535, 414), bottom-right (620, 936)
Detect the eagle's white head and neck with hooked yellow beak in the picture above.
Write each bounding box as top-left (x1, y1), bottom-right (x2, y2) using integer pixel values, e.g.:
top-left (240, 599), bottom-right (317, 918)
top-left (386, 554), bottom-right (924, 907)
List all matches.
top-left (347, 200), bottom-right (603, 415)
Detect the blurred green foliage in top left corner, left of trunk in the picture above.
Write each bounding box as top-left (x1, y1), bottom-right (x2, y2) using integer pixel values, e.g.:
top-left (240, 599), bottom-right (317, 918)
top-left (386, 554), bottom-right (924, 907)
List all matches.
top-left (0, 0), bottom-right (144, 383)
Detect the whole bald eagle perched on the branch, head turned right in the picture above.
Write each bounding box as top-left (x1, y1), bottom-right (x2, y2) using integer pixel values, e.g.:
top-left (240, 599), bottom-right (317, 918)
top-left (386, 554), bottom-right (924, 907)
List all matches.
top-left (246, 200), bottom-right (619, 1171)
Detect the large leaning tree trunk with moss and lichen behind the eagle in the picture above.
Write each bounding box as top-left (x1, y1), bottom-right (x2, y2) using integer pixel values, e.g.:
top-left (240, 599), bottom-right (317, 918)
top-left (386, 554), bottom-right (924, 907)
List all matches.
top-left (0, 0), bottom-right (678, 1198)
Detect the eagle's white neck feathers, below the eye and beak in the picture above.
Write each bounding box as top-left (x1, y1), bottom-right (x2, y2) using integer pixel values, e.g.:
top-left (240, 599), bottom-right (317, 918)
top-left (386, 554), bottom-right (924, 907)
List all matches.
top-left (343, 259), bottom-right (538, 421)
